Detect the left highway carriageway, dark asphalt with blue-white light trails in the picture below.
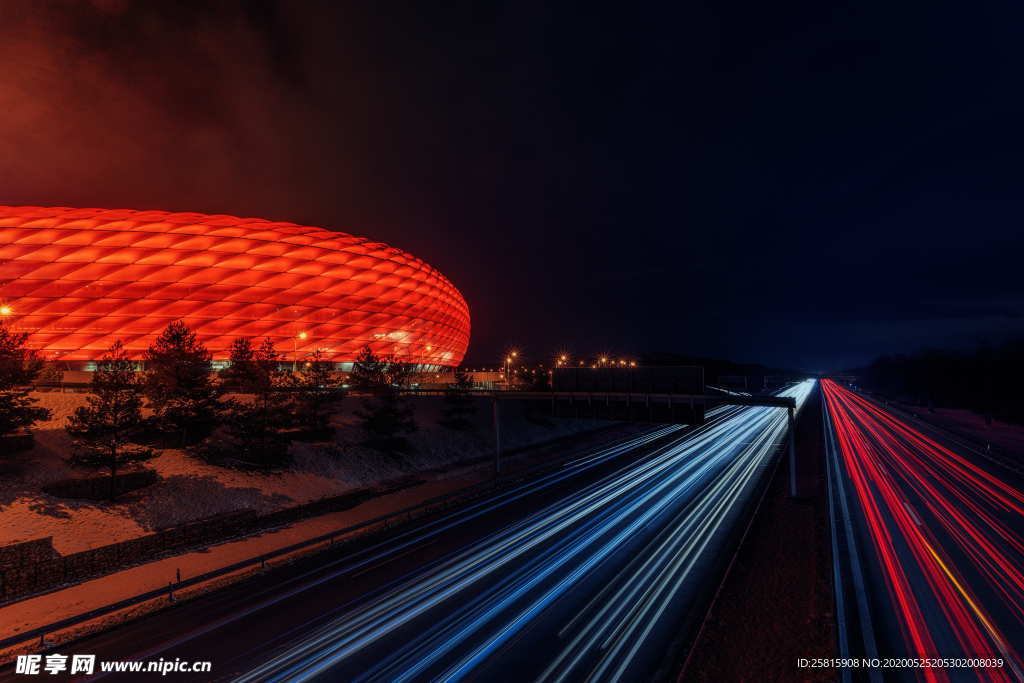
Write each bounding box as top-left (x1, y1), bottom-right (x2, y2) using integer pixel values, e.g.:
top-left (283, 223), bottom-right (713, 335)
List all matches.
top-left (0, 382), bottom-right (814, 681)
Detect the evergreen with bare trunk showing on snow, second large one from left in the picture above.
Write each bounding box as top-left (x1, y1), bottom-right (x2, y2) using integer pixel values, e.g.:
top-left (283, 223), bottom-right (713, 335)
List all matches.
top-left (68, 340), bottom-right (156, 501)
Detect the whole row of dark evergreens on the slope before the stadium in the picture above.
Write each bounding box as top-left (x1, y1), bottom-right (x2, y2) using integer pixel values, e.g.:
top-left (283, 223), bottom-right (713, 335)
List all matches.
top-left (0, 321), bottom-right (476, 499)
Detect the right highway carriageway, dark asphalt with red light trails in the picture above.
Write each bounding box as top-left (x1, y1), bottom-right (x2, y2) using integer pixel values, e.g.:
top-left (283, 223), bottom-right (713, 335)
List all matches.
top-left (821, 380), bottom-right (1024, 681)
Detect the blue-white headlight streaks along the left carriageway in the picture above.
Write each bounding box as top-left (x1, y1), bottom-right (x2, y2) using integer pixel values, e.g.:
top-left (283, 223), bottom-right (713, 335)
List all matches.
top-left (240, 382), bottom-right (813, 681)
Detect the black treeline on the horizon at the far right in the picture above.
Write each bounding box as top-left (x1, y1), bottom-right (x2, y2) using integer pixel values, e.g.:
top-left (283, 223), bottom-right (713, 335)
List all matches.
top-left (854, 339), bottom-right (1024, 424)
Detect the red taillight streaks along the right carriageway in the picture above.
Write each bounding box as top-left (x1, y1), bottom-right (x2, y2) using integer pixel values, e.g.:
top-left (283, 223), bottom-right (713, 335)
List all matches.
top-left (822, 380), bottom-right (1024, 681)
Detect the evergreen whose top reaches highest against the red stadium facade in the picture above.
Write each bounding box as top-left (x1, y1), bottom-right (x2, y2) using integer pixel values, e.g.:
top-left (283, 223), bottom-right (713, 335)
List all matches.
top-left (144, 321), bottom-right (222, 445)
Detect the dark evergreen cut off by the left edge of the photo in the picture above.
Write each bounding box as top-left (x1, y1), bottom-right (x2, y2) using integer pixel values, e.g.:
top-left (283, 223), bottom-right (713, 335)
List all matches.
top-left (0, 323), bottom-right (50, 436)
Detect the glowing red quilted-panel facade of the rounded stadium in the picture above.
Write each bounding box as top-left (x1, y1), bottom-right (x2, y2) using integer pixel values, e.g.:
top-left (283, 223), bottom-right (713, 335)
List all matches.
top-left (0, 207), bottom-right (470, 367)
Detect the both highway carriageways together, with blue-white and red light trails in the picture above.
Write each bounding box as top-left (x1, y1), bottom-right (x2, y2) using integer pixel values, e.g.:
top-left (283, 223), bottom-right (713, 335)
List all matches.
top-left (6, 380), bottom-right (1024, 681)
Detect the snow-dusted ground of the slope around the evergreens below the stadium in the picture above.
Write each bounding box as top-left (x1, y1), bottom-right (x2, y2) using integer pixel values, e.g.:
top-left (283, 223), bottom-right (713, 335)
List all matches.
top-left (0, 392), bottom-right (603, 554)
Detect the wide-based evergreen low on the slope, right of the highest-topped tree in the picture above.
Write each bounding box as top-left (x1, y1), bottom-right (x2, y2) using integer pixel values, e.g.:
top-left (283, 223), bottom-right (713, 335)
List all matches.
top-left (219, 339), bottom-right (294, 467)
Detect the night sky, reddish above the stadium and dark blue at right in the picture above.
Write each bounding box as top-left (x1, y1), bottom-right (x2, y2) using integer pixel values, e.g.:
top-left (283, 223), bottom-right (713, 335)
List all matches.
top-left (0, 0), bottom-right (1024, 370)
